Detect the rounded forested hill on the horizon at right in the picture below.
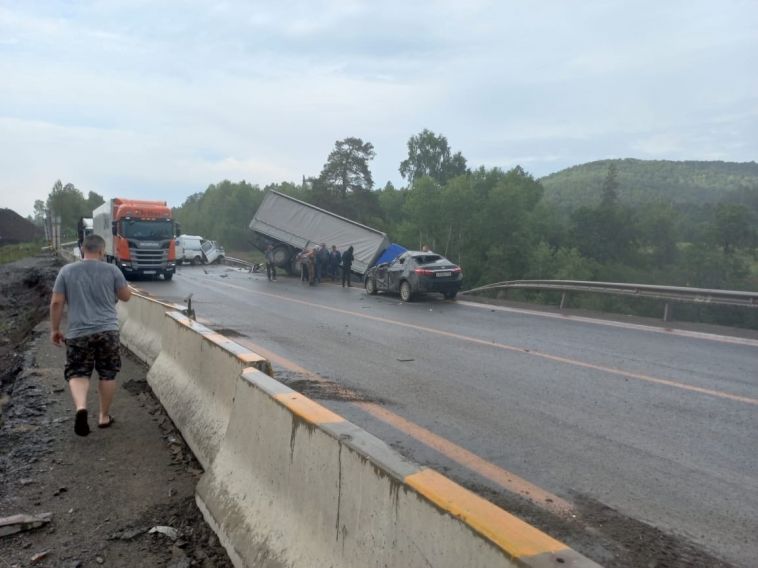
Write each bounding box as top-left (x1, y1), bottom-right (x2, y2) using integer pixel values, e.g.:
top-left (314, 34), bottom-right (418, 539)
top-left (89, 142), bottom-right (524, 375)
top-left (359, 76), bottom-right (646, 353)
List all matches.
top-left (540, 159), bottom-right (758, 209)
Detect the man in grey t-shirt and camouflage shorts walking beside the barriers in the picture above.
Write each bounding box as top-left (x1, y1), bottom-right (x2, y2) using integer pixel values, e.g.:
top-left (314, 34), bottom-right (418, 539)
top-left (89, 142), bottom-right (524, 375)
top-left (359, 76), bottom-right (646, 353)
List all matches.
top-left (50, 235), bottom-right (131, 436)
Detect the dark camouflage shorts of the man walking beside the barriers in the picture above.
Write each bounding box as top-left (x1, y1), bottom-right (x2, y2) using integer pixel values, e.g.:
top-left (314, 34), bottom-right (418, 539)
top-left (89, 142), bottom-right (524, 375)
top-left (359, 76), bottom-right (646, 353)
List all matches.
top-left (64, 331), bottom-right (121, 381)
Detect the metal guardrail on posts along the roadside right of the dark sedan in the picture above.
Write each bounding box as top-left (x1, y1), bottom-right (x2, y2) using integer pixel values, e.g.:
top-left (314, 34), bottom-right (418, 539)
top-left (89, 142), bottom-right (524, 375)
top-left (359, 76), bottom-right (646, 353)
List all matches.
top-left (461, 280), bottom-right (758, 321)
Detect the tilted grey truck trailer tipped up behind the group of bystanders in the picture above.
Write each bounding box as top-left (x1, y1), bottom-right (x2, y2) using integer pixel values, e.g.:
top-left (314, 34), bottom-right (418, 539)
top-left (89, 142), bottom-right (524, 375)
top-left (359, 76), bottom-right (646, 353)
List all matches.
top-left (250, 191), bottom-right (390, 275)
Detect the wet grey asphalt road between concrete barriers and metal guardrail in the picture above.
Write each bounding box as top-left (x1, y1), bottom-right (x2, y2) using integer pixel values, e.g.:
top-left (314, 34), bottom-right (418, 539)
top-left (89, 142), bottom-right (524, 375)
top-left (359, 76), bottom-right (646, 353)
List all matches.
top-left (134, 266), bottom-right (758, 566)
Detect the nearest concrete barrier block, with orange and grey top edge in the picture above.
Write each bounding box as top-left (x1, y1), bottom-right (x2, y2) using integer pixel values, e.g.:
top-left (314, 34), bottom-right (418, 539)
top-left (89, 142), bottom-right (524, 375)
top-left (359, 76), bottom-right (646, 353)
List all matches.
top-left (197, 369), bottom-right (596, 568)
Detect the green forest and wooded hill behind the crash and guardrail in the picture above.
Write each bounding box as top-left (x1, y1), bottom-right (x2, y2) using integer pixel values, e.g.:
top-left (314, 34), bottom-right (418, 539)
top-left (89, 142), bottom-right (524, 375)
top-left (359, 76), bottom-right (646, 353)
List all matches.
top-left (34, 130), bottom-right (758, 327)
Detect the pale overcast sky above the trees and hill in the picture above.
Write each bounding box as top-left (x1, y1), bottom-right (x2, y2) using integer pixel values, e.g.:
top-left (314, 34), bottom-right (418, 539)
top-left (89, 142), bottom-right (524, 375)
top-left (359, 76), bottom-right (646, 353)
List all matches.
top-left (0, 0), bottom-right (758, 215)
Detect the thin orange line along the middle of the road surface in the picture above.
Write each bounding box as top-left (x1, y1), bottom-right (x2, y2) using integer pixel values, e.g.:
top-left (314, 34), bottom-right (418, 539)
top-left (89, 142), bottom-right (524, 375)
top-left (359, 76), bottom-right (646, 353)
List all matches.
top-left (209, 282), bottom-right (758, 405)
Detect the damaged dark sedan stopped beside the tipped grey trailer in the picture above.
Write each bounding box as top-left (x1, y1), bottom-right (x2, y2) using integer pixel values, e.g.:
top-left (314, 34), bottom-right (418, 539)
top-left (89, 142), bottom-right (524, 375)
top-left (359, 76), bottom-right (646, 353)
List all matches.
top-left (364, 251), bottom-right (463, 302)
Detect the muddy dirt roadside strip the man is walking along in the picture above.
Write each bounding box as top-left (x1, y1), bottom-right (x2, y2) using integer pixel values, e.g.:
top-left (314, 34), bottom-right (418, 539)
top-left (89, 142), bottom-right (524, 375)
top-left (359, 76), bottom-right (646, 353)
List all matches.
top-left (0, 256), bottom-right (231, 568)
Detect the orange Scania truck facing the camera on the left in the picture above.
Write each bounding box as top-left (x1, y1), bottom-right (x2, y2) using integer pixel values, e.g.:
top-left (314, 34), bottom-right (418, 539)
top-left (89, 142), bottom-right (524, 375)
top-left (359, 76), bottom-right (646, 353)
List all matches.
top-left (92, 197), bottom-right (177, 280)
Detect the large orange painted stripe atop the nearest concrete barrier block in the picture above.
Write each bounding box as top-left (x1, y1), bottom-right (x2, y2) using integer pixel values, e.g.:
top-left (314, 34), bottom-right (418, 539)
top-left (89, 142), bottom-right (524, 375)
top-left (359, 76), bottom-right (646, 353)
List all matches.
top-left (405, 469), bottom-right (570, 558)
